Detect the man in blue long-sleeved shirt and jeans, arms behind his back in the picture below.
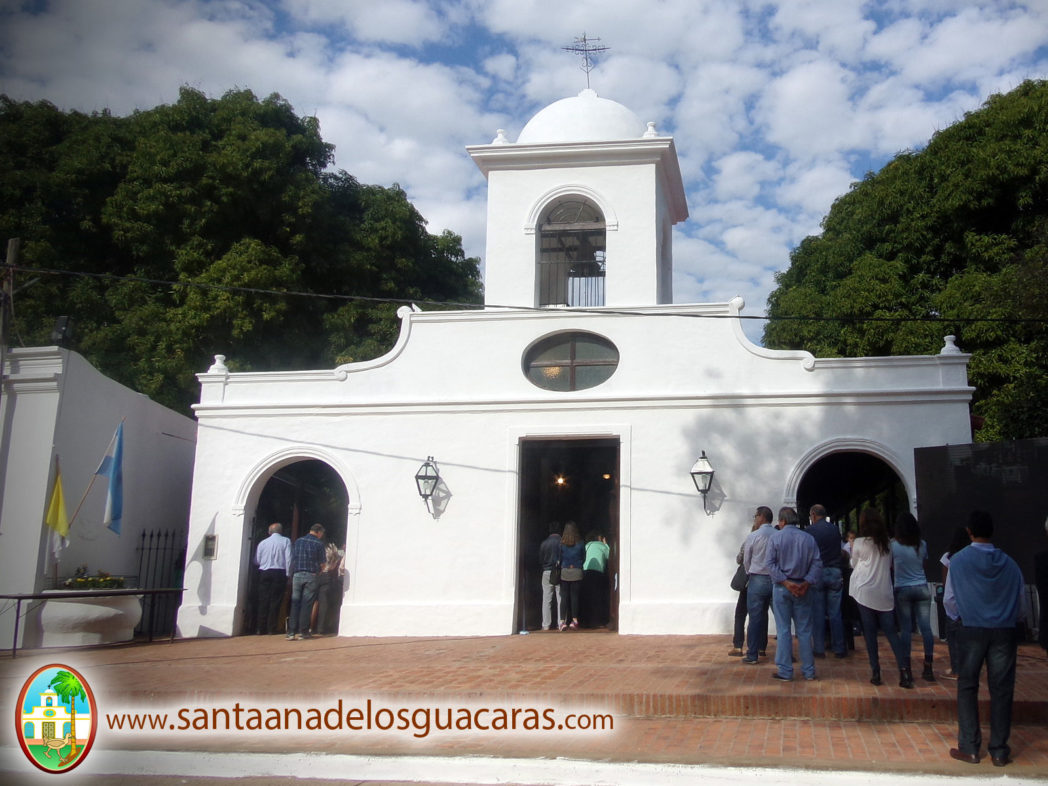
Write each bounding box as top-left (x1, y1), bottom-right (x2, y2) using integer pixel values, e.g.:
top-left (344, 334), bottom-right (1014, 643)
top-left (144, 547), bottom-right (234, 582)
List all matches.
top-left (768, 507), bottom-right (823, 682)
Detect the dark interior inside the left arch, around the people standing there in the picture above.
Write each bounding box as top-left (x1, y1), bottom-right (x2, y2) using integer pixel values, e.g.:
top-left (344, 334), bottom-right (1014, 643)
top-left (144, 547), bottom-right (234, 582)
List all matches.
top-left (241, 459), bottom-right (349, 634)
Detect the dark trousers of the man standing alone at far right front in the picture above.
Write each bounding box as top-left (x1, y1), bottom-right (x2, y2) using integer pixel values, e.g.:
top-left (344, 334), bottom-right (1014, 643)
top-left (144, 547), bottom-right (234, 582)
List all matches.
top-left (957, 625), bottom-right (1019, 759)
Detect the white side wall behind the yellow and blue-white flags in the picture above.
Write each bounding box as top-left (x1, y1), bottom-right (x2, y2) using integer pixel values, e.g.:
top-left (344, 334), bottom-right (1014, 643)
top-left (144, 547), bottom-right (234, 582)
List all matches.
top-left (0, 347), bottom-right (196, 647)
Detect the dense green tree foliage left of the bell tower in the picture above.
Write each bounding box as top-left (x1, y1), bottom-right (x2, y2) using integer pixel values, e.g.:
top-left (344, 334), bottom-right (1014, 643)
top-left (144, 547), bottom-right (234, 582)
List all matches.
top-left (0, 88), bottom-right (481, 411)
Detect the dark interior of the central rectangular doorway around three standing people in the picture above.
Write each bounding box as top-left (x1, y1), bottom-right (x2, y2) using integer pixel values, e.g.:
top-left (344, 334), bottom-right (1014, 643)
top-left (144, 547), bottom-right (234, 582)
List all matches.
top-left (515, 439), bottom-right (619, 631)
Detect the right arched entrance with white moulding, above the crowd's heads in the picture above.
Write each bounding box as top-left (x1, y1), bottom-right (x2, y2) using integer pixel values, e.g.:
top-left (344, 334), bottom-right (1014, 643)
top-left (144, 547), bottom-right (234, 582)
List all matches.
top-left (785, 440), bottom-right (915, 529)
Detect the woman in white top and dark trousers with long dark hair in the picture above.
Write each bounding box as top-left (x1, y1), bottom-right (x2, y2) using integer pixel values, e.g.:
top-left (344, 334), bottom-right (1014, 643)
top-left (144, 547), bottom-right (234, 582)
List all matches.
top-left (848, 507), bottom-right (914, 687)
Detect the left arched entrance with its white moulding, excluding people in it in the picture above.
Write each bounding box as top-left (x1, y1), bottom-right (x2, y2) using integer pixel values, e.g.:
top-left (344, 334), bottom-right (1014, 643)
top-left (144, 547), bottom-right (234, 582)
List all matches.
top-left (236, 449), bottom-right (359, 634)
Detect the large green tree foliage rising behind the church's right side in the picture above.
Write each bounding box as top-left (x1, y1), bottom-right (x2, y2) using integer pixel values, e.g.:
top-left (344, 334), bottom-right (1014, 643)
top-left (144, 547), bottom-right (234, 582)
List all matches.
top-left (764, 81), bottom-right (1048, 440)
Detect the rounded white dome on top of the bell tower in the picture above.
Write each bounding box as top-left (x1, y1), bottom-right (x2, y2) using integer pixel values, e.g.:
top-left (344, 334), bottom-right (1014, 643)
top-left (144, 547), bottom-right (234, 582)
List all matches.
top-left (517, 89), bottom-right (645, 145)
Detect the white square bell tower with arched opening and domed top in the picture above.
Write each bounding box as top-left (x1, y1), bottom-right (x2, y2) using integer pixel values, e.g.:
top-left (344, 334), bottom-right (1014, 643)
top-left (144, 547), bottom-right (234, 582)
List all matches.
top-left (466, 88), bottom-right (687, 308)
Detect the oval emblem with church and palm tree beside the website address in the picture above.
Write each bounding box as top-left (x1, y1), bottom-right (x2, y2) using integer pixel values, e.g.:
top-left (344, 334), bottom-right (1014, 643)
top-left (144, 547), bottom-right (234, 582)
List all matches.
top-left (15, 663), bottom-right (99, 772)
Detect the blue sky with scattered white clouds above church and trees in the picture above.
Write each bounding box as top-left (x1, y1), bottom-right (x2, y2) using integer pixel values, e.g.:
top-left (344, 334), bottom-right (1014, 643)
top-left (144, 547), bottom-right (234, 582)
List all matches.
top-left (0, 0), bottom-right (1048, 332)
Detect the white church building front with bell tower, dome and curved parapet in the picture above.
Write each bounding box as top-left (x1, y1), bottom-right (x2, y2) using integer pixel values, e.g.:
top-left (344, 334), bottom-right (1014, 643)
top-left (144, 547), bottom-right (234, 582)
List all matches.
top-left (178, 90), bottom-right (973, 636)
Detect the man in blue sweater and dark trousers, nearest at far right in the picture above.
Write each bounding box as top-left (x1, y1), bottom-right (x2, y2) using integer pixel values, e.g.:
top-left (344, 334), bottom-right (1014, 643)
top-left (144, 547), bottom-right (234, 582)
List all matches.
top-left (942, 510), bottom-right (1023, 767)
